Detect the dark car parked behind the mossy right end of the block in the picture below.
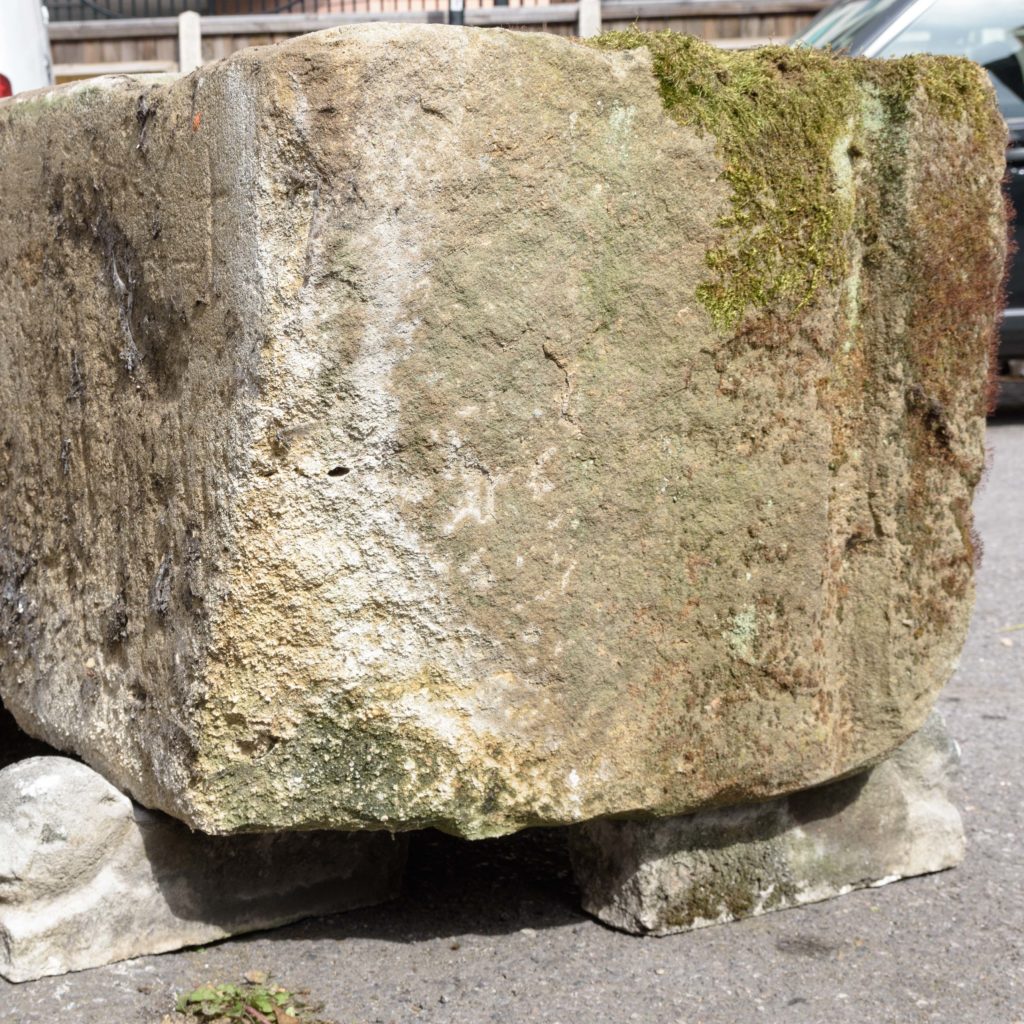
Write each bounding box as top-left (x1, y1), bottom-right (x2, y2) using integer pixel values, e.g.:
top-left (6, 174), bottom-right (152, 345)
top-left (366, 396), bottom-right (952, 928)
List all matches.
top-left (794, 0), bottom-right (1024, 376)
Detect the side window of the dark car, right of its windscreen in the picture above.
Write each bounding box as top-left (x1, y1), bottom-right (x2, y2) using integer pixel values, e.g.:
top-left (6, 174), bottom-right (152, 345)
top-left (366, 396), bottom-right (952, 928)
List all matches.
top-left (879, 0), bottom-right (1024, 118)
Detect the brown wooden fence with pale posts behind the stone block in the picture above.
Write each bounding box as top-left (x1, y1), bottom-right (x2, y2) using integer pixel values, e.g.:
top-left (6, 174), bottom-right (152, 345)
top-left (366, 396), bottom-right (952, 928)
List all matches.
top-left (50, 0), bottom-right (825, 82)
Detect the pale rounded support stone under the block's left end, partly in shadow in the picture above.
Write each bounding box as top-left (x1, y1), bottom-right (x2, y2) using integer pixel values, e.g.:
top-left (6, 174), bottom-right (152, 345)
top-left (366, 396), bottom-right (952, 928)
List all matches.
top-left (0, 757), bottom-right (406, 981)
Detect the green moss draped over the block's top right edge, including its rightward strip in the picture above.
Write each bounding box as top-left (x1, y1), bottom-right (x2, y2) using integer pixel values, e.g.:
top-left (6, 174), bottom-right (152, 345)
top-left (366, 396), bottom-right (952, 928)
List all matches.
top-left (592, 31), bottom-right (993, 330)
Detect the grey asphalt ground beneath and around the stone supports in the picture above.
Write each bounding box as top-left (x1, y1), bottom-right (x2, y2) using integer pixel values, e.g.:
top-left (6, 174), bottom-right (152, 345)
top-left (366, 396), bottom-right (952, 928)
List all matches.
top-left (0, 416), bottom-right (1024, 1024)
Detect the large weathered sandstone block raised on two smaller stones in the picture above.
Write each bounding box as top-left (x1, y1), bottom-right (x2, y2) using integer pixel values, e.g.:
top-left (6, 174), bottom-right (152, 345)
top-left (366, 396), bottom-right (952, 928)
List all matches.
top-left (0, 26), bottom-right (1006, 836)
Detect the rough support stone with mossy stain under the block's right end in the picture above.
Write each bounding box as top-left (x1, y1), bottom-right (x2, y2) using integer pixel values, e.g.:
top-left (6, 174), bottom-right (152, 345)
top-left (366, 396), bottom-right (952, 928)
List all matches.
top-left (571, 714), bottom-right (966, 935)
